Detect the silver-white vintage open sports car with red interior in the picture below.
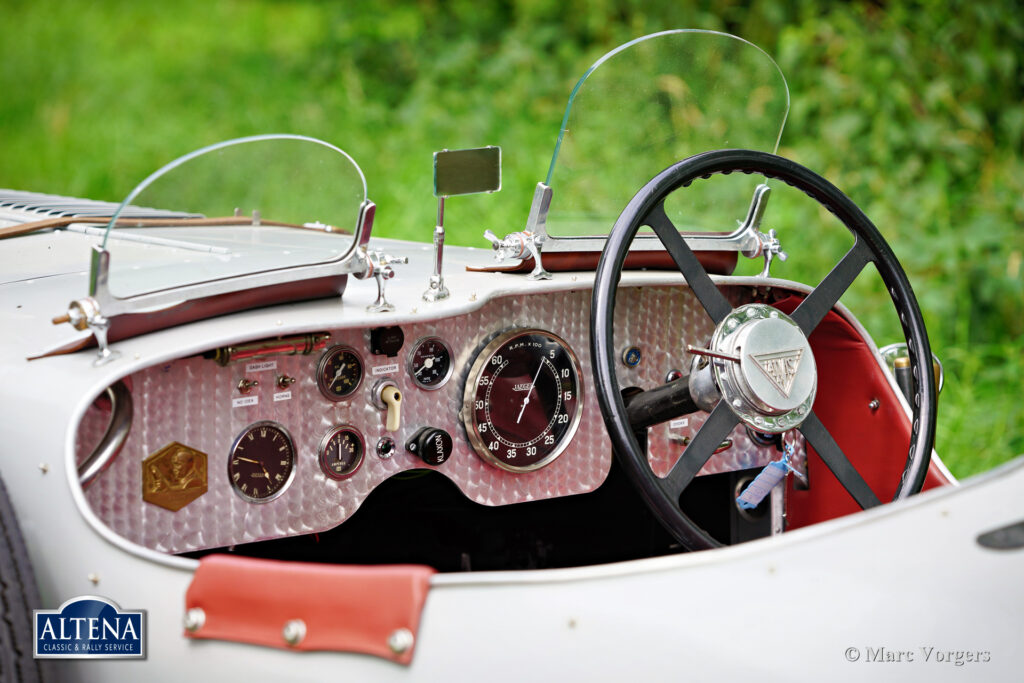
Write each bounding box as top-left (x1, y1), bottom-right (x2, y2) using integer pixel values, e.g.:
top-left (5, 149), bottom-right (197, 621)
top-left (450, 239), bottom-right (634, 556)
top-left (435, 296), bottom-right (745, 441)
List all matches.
top-left (0, 31), bottom-right (1024, 681)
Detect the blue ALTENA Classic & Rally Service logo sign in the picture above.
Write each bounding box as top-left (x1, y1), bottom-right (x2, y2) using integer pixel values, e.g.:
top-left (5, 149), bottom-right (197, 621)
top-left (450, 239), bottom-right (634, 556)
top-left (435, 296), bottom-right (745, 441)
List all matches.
top-left (33, 595), bottom-right (145, 659)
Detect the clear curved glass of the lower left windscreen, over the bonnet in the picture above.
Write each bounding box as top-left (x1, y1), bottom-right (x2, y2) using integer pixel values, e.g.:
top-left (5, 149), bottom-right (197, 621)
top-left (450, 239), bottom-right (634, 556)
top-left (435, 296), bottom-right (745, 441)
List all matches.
top-left (96, 135), bottom-right (367, 298)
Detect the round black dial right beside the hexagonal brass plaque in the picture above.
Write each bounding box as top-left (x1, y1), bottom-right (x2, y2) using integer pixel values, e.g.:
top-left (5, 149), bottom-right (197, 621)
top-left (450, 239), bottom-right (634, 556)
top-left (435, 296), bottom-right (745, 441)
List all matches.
top-left (227, 420), bottom-right (295, 503)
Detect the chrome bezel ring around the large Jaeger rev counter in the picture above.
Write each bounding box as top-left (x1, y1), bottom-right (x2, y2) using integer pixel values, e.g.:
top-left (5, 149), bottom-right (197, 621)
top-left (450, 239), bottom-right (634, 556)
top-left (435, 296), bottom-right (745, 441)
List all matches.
top-left (460, 328), bottom-right (586, 474)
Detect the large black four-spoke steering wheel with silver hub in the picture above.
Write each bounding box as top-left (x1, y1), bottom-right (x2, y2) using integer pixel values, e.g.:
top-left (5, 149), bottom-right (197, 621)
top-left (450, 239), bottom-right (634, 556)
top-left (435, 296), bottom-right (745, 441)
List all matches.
top-left (591, 150), bottom-right (936, 550)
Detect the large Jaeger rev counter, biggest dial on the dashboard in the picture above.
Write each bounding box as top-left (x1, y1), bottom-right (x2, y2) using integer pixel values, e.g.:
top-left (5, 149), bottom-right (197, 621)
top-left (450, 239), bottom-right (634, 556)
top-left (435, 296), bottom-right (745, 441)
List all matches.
top-left (462, 330), bottom-right (583, 472)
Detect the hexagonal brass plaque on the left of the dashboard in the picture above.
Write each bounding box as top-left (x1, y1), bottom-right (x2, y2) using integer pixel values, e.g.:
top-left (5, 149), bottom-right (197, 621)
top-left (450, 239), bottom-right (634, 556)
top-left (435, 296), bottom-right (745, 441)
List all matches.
top-left (142, 441), bottom-right (207, 512)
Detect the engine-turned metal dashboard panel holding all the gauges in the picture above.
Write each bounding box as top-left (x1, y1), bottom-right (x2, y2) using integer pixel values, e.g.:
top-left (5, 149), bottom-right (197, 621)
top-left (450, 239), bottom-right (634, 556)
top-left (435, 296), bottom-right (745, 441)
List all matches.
top-left (77, 287), bottom-right (802, 553)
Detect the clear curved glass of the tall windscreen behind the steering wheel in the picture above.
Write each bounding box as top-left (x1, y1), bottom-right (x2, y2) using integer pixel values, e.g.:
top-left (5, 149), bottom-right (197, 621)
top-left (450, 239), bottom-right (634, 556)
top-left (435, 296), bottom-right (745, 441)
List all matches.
top-left (546, 30), bottom-right (790, 237)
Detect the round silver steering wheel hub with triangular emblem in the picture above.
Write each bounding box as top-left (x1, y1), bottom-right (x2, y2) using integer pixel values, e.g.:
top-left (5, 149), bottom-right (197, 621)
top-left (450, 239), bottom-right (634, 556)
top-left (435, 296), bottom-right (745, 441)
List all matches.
top-left (694, 304), bottom-right (817, 434)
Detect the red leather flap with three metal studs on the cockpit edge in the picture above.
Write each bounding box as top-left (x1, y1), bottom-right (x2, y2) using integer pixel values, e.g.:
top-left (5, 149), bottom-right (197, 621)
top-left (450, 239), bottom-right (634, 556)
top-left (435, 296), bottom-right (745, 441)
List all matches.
top-left (185, 555), bottom-right (434, 665)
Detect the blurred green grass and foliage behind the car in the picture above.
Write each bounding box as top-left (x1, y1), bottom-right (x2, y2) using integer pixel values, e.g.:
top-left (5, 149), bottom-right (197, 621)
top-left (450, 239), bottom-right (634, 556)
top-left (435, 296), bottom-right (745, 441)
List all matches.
top-left (0, 0), bottom-right (1024, 475)
